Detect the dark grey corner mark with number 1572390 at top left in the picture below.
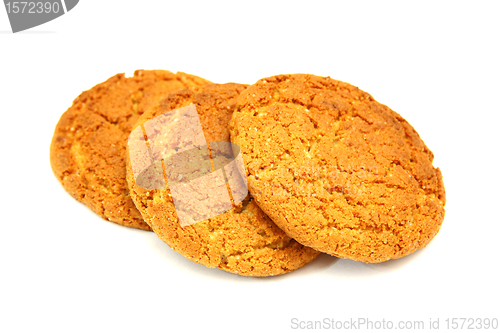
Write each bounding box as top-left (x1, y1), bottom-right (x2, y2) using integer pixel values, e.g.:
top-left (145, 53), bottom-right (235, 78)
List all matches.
top-left (4, 0), bottom-right (79, 33)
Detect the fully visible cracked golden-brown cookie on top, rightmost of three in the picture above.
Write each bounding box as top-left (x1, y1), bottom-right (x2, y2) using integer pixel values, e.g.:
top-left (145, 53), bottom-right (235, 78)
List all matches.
top-left (230, 74), bottom-right (445, 262)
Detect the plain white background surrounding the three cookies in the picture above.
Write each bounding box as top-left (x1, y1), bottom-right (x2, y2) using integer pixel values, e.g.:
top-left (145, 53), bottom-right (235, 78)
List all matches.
top-left (0, 0), bottom-right (500, 332)
